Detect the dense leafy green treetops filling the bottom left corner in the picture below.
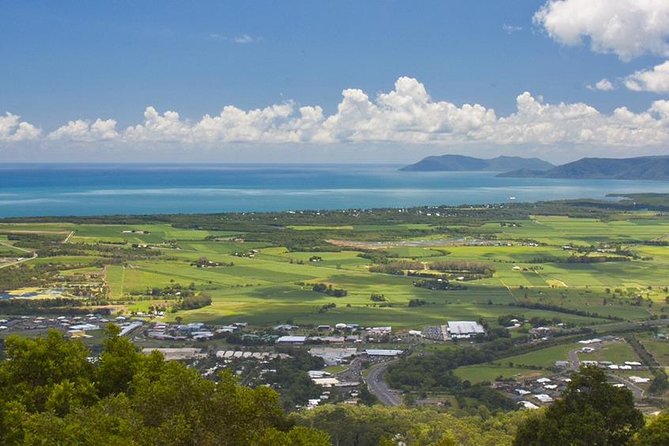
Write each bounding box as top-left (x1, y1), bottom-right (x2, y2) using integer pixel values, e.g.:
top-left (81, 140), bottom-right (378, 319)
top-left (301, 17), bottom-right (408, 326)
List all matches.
top-left (0, 328), bottom-right (329, 446)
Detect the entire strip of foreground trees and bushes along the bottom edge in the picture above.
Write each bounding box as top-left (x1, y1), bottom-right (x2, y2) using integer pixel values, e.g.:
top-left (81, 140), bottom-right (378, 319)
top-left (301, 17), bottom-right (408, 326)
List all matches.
top-left (0, 326), bottom-right (669, 446)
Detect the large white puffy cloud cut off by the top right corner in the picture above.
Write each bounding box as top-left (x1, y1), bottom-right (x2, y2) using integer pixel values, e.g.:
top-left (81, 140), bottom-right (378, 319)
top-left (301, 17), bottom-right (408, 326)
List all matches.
top-left (534, 0), bottom-right (669, 60)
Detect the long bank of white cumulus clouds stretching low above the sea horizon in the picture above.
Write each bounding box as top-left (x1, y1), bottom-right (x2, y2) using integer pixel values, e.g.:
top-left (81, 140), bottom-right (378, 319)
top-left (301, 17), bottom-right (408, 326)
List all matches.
top-left (0, 77), bottom-right (669, 147)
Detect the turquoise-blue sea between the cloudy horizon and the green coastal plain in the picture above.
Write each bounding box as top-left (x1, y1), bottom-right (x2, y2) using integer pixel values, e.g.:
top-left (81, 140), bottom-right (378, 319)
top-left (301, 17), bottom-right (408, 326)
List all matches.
top-left (0, 164), bottom-right (669, 217)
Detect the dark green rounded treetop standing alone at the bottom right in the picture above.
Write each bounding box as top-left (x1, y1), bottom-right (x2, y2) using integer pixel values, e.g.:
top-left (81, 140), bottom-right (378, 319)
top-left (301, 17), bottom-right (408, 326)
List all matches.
top-left (514, 367), bottom-right (644, 446)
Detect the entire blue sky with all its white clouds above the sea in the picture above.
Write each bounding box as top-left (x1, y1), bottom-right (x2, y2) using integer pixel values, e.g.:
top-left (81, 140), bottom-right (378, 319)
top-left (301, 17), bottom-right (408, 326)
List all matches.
top-left (0, 0), bottom-right (669, 163)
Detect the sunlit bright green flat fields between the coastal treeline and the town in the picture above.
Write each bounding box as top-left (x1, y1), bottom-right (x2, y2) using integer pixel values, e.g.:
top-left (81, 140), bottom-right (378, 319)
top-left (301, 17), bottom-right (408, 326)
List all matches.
top-left (0, 207), bottom-right (669, 330)
